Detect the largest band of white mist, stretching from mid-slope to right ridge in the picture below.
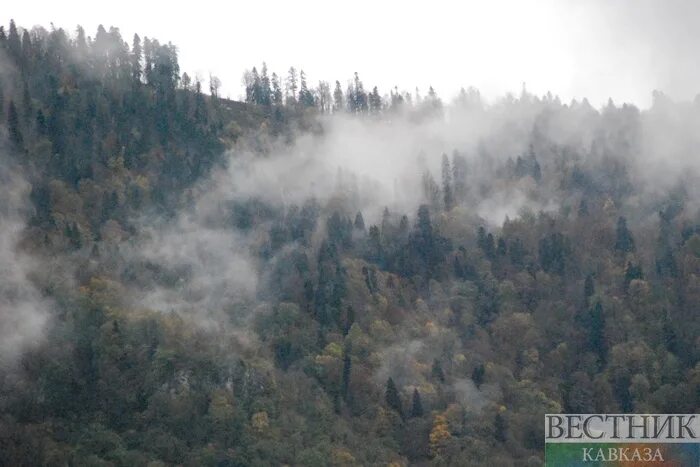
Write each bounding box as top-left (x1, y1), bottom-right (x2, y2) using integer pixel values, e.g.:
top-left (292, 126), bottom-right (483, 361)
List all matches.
top-left (120, 94), bottom-right (700, 327)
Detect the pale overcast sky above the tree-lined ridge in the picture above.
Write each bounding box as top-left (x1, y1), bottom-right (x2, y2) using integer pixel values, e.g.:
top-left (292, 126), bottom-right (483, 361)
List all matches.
top-left (3, 0), bottom-right (700, 107)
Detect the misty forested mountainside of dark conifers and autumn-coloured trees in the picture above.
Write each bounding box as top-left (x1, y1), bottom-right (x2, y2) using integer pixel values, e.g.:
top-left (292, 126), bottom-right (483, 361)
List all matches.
top-left (0, 22), bottom-right (700, 467)
